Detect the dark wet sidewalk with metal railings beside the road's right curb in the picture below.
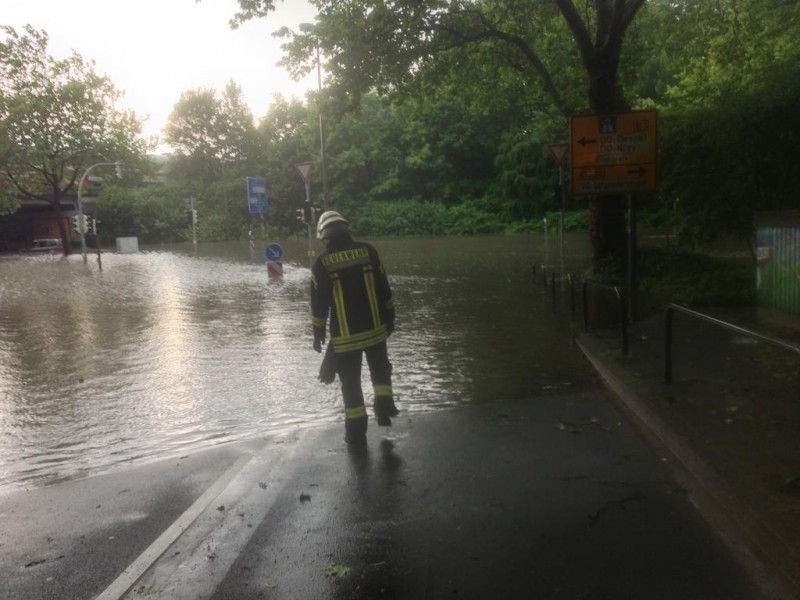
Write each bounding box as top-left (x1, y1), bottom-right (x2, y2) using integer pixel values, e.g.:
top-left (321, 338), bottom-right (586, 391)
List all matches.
top-left (577, 314), bottom-right (800, 597)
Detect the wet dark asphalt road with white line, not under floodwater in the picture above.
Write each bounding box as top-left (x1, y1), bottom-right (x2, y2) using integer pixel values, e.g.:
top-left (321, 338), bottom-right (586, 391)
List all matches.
top-left (0, 384), bottom-right (769, 600)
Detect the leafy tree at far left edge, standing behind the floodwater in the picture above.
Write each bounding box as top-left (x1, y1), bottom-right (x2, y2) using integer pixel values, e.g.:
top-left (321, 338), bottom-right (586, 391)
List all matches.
top-left (0, 25), bottom-right (148, 251)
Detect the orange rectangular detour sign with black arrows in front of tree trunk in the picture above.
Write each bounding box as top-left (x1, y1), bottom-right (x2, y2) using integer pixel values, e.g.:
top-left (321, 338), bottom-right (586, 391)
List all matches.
top-left (570, 110), bottom-right (658, 195)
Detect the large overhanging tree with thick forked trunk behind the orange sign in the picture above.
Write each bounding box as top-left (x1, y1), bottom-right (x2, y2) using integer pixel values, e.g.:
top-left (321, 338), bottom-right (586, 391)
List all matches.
top-left (223, 0), bottom-right (645, 259)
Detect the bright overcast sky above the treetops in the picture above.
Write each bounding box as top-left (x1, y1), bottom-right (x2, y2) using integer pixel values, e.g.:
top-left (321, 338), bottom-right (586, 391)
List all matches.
top-left (6, 0), bottom-right (317, 145)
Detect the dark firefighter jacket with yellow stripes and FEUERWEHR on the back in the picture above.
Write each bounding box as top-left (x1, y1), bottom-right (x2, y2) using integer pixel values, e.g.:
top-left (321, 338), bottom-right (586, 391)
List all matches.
top-left (311, 238), bottom-right (394, 352)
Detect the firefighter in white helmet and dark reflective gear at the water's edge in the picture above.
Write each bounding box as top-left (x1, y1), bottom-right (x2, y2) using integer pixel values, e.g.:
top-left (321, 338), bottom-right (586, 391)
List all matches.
top-left (311, 210), bottom-right (398, 445)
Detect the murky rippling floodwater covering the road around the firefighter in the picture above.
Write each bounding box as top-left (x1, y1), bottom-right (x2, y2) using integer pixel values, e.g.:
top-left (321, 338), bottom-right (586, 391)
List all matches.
top-left (0, 235), bottom-right (590, 491)
